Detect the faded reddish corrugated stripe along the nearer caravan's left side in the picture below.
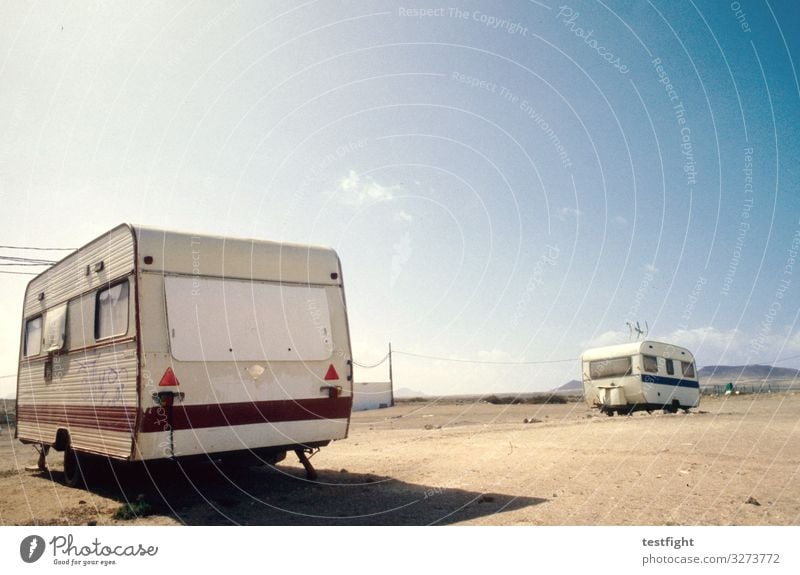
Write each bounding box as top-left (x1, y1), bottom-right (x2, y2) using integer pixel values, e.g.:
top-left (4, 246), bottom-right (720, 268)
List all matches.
top-left (17, 405), bottom-right (138, 433)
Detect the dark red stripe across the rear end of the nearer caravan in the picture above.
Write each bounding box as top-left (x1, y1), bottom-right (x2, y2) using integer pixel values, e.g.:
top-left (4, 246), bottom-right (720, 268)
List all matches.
top-left (140, 397), bottom-right (353, 433)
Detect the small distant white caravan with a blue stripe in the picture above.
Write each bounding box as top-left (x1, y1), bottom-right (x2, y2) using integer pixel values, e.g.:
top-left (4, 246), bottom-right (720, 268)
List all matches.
top-left (581, 341), bottom-right (700, 415)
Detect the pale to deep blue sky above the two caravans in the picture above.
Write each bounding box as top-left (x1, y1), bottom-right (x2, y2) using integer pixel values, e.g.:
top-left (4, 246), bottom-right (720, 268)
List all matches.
top-left (0, 0), bottom-right (800, 395)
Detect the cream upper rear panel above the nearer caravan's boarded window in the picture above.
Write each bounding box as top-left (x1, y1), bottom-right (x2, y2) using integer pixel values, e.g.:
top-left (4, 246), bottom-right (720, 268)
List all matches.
top-left (136, 227), bottom-right (341, 285)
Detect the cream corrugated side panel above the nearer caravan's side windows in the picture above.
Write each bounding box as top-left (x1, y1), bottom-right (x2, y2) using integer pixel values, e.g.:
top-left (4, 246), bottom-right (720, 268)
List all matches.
top-left (24, 226), bottom-right (134, 317)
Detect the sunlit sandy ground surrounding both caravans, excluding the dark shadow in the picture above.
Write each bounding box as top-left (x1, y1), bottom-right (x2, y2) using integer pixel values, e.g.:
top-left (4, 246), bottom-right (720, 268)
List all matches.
top-left (0, 394), bottom-right (800, 525)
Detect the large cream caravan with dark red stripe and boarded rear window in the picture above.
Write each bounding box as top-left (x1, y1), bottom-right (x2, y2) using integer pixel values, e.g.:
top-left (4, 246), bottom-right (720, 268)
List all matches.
top-left (17, 225), bottom-right (352, 474)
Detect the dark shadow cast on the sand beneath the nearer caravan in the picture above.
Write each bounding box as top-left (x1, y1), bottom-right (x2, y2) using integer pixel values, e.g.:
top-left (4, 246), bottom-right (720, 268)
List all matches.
top-left (42, 456), bottom-right (546, 525)
